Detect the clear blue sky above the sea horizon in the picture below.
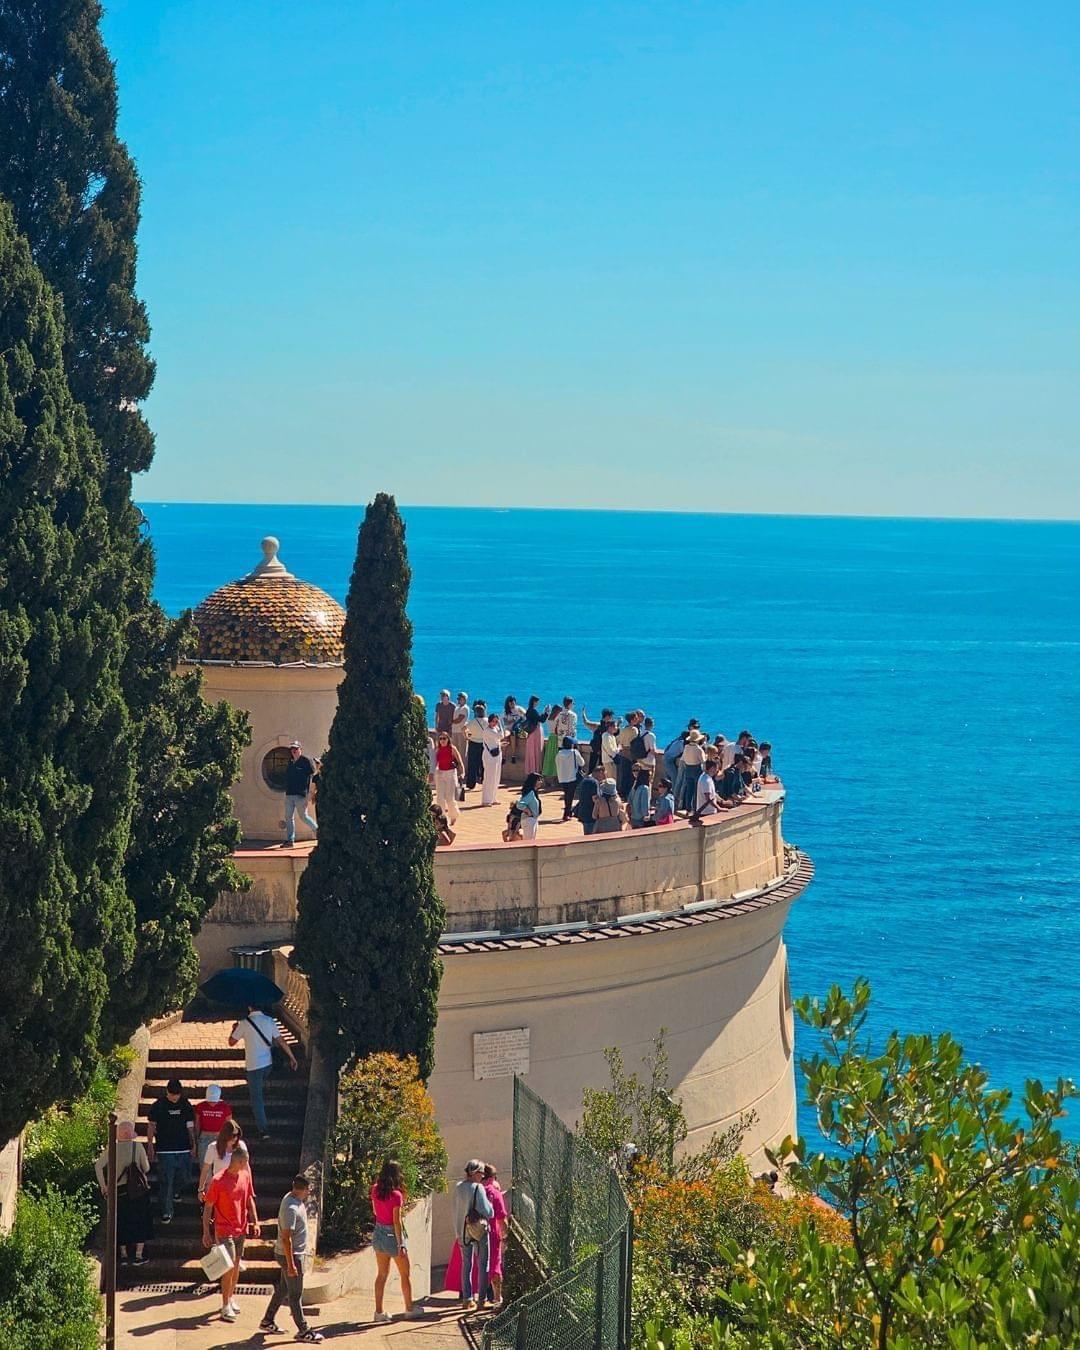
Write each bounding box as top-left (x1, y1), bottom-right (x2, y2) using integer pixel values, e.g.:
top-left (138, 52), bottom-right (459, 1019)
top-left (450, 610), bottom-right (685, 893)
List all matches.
top-left (105, 0), bottom-right (1080, 518)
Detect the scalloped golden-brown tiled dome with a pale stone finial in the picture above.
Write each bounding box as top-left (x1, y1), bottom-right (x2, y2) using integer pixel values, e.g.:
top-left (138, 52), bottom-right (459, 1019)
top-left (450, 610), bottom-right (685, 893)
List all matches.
top-left (194, 539), bottom-right (346, 666)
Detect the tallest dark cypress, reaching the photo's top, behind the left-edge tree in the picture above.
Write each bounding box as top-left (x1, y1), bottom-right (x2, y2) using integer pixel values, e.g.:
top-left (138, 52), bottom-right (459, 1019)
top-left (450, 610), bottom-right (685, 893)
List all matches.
top-left (0, 0), bottom-right (246, 1040)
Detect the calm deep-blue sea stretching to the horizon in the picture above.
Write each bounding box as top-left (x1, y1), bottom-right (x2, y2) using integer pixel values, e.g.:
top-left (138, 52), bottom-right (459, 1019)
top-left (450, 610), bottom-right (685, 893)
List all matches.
top-left (144, 505), bottom-right (1080, 1138)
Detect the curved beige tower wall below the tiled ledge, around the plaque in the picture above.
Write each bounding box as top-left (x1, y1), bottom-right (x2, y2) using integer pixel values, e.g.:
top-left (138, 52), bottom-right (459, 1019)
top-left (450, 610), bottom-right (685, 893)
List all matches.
top-left (431, 900), bottom-right (795, 1264)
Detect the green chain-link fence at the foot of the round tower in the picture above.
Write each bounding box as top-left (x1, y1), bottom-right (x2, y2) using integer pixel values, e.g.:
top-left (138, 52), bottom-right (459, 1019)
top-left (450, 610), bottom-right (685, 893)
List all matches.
top-left (483, 1079), bottom-right (633, 1350)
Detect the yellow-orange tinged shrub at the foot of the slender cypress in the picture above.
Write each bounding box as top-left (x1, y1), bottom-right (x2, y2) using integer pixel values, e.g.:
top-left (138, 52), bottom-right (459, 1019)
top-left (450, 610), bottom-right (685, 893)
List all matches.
top-left (323, 1053), bottom-right (447, 1247)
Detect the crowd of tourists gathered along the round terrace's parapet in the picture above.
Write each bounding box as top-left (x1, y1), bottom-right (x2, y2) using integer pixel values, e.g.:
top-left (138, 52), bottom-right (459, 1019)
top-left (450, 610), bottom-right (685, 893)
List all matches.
top-left (429, 690), bottom-right (775, 844)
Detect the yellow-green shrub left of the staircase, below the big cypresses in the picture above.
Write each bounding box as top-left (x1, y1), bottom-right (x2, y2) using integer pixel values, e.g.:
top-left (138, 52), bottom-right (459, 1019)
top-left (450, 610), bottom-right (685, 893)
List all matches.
top-left (23, 1045), bottom-right (135, 1195)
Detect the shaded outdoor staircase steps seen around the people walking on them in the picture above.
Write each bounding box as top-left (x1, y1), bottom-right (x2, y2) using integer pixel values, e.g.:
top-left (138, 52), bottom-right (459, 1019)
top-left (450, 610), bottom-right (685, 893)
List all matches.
top-left (133, 1015), bottom-right (308, 1285)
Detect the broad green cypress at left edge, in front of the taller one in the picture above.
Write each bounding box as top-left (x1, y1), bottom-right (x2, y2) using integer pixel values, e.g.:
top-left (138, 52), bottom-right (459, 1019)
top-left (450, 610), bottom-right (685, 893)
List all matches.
top-left (0, 201), bottom-right (134, 1139)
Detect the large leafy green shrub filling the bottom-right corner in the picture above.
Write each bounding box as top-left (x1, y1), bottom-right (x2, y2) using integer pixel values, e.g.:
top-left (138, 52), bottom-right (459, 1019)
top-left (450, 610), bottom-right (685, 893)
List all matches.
top-left (697, 981), bottom-right (1080, 1350)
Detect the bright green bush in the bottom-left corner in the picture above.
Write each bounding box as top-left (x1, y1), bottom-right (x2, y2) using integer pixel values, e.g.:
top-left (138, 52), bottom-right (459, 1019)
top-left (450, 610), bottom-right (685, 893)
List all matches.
top-left (0, 1189), bottom-right (101, 1350)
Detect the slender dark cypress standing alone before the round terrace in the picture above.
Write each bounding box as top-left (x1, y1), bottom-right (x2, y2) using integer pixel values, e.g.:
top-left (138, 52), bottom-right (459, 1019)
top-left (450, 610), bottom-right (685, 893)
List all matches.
top-left (296, 493), bottom-right (446, 1079)
